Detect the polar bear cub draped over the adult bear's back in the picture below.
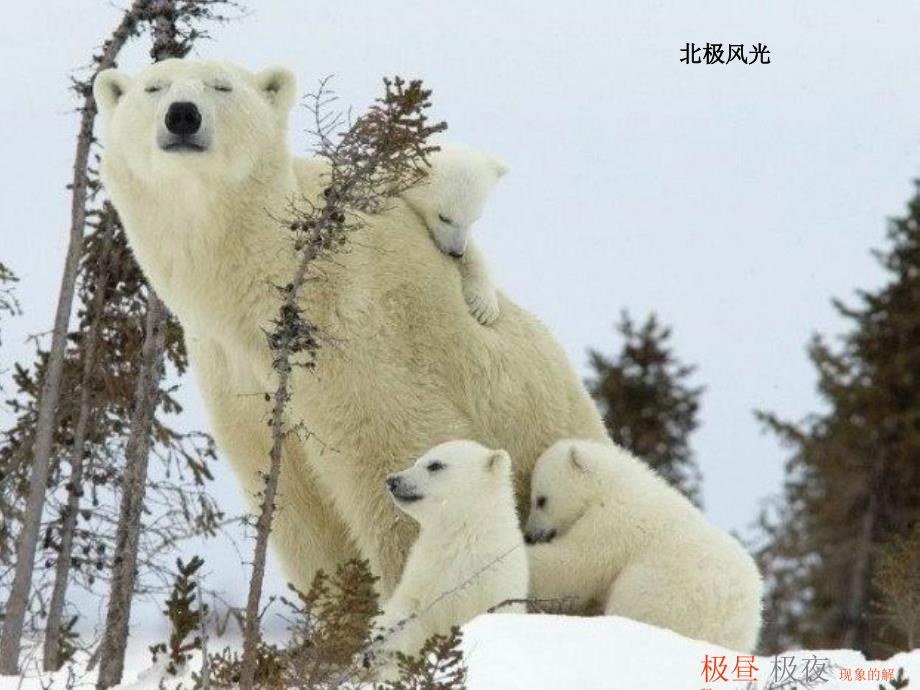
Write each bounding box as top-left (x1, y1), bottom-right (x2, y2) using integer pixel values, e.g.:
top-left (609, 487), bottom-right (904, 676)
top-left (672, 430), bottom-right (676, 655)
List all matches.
top-left (402, 144), bottom-right (508, 326)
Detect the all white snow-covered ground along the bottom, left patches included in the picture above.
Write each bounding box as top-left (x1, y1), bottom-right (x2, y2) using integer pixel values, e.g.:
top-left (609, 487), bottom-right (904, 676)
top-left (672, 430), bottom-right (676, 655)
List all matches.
top-left (0, 614), bottom-right (920, 690)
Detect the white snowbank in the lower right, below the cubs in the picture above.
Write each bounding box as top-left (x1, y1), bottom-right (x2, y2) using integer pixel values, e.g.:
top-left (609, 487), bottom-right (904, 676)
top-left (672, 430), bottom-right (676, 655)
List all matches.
top-left (464, 614), bottom-right (920, 690)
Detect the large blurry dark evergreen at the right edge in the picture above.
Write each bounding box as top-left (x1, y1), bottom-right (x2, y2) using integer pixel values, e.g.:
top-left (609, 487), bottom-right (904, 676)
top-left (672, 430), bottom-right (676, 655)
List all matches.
top-left (759, 180), bottom-right (920, 656)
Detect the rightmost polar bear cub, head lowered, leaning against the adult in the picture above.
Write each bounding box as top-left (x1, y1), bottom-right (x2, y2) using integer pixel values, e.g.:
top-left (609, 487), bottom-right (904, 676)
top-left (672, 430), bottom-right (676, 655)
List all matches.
top-left (525, 439), bottom-right (763, 651)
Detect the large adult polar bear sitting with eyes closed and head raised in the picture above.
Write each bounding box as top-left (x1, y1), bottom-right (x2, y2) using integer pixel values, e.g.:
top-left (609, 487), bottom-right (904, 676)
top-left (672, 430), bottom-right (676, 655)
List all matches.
top-left (94, 60), bottom-right (605, 594)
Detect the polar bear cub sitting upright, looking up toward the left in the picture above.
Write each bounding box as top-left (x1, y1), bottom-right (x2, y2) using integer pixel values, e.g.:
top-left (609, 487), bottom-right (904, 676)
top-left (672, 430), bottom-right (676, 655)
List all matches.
top-left (376, 441), bottom-right (528, 654)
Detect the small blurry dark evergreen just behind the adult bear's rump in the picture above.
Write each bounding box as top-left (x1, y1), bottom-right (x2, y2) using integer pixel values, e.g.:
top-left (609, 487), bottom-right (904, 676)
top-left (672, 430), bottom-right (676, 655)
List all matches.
top-left (586, 312), bottom-right (703, 506)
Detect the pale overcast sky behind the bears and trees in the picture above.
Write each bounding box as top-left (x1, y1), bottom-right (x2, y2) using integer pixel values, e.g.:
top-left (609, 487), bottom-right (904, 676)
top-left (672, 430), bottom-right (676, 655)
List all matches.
top-left (0, 0), bottom-right (920, 628)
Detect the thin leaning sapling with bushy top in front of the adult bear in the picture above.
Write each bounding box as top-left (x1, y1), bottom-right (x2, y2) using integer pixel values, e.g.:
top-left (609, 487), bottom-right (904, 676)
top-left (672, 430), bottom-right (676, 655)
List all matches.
top-left (240, 77), bottom-right (446, 690)
